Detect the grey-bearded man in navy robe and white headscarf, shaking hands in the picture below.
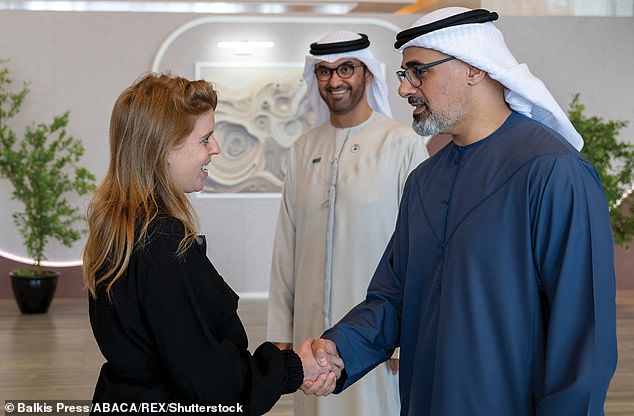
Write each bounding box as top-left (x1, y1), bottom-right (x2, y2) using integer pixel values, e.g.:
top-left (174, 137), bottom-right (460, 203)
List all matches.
top-left (304, 7), bottom-right (617, 416)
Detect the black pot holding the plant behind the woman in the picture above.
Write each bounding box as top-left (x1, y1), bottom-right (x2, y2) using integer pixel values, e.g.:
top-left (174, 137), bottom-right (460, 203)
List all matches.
top-left (10, 271), bottom-right (59, 314)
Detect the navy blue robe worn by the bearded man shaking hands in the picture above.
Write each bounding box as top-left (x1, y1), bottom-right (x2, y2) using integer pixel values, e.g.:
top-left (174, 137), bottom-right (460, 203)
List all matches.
top-left (323, 112), bottom-right (617, 416)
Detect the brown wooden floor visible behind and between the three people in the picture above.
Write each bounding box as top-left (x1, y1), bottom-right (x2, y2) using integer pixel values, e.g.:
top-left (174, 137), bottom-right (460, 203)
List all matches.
top-left (0, 290), bottom-right (634, 416)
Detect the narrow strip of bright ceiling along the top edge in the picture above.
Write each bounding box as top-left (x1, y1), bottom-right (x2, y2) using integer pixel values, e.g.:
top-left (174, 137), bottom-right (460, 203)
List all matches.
top-left (0, 0), bottom-right (634, 17)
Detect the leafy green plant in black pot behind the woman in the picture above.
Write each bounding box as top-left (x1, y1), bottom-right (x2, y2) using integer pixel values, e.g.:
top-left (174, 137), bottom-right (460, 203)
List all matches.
top-left (0, 60), bottom-right (95, 313)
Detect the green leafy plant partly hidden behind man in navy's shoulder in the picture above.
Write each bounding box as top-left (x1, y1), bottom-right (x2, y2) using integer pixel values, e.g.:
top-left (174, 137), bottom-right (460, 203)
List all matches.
top-left (568, 93), bottom-right (634, 248)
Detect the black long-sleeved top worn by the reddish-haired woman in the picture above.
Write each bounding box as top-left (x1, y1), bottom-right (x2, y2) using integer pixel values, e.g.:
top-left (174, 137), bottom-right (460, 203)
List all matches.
top-left (89, 219), bottom-right (303, 415)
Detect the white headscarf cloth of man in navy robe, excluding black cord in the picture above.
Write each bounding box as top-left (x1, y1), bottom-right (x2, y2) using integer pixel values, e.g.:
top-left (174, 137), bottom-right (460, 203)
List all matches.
top-left (398, 7), bottom-right (583, 150)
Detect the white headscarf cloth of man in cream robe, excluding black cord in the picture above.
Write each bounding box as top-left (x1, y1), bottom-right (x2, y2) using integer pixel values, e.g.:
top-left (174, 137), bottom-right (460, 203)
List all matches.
top-left (303, 30), bottom-right (392, 126)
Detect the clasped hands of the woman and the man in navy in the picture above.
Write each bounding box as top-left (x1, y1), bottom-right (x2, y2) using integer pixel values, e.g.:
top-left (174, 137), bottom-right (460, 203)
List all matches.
top-left (295, 338), bottom-right (343, 396)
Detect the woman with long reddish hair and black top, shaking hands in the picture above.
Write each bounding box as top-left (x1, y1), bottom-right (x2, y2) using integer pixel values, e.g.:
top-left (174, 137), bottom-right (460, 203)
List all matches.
top-left (83, 73), bottom-right (340, 414)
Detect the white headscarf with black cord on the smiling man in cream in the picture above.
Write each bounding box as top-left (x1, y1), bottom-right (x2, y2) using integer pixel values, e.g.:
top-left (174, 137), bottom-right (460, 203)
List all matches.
top-left (303, 30), bottom-right (392, 127)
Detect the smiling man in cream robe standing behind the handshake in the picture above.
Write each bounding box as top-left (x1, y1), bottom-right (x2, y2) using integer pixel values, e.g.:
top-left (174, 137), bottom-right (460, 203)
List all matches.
top-left (267, 31), bottom-right (428, 416)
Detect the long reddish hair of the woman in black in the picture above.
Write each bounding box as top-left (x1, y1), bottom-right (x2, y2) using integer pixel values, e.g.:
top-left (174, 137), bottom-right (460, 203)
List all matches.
top-left (83, 73), bottom-right (217, 296)
